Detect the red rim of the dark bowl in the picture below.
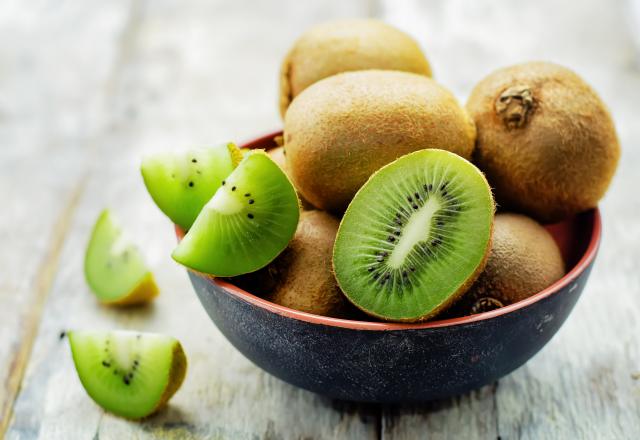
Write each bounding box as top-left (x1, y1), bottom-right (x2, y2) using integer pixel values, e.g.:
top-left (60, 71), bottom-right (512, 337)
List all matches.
top-left (176, 132), bottom-right (602, 330)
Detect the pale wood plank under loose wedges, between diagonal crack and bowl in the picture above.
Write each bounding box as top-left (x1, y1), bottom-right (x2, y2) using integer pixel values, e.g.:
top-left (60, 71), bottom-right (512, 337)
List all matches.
top-left (7, 0), bottom-right (379, 439)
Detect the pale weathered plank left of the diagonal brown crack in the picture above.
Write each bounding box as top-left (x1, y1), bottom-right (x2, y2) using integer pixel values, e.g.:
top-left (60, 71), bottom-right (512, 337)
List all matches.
top-left (0, 2), bottom-right (135, 437)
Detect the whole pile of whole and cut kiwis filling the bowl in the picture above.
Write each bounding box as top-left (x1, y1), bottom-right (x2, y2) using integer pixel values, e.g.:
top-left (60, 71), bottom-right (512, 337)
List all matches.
top-left (149, 20), bottom-right (620, 322)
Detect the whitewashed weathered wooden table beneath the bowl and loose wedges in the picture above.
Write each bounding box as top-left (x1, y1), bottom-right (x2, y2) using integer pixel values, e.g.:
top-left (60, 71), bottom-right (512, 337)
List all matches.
top-left (0, 0), bottom-right (640, 439)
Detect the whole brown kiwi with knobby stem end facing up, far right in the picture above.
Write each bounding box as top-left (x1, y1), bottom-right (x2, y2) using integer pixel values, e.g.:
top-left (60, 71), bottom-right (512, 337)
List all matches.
top-left (467, 62), bottom-right (620, 222)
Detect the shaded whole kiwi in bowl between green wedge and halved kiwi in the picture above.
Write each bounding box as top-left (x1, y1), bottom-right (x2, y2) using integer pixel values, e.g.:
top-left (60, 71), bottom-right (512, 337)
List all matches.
top-left (232, 210), bottom-right (349, 317)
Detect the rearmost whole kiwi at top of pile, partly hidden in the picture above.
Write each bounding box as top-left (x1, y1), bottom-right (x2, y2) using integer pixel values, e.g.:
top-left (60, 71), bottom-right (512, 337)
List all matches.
top-left (280, 19), bottom-right (431, 116)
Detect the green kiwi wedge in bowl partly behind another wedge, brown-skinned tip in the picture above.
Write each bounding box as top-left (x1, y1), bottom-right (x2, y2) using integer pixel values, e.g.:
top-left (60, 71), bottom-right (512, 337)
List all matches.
top-left (140, 143), bottom-right (242, 229)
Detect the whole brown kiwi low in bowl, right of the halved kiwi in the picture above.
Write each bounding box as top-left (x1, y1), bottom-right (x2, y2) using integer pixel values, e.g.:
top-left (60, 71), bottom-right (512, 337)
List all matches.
top-left (455, 213), bottom-right (565, 315)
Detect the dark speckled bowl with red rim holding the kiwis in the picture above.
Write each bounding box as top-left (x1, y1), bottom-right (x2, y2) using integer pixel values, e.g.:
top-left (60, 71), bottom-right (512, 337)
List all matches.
top-left (176, 133), bottom-right (601, 403)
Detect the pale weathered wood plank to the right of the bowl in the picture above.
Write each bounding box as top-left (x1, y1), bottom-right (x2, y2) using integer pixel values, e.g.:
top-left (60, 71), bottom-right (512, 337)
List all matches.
top-left (381, 0), bottom-right (640, 439)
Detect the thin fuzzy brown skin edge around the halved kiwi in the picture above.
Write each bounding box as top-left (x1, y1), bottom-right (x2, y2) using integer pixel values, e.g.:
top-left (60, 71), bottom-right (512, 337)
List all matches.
top-left (331, 155), bottom-right (496, 323)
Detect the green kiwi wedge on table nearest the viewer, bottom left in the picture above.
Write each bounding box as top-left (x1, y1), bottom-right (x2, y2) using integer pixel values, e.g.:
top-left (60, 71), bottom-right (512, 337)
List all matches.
top-left (68, 331), bottom-right (187, 419)
